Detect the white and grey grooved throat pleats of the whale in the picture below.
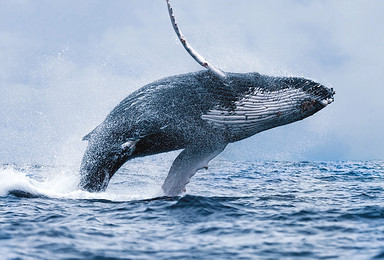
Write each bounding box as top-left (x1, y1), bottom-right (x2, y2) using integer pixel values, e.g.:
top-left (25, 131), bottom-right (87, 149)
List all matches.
top-left (201, 88), bottom-right (312, 141)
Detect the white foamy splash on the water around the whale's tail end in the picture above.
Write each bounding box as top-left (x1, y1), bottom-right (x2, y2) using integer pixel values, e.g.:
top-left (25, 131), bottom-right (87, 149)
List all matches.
top-left (0, 166), bottom-right (161, 201)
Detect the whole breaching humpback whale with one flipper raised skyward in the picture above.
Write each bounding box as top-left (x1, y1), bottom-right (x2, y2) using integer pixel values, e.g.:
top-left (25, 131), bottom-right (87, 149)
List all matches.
top-left (79, 0), bottom-right (335, 196)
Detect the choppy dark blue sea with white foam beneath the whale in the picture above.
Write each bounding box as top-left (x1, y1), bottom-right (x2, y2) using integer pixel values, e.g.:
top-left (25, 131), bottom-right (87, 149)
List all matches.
top-left (0, 160), bottom-right (384, 259)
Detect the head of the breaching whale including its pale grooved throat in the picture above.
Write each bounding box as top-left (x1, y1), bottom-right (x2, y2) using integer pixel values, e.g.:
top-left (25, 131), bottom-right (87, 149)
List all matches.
top-left (202, 73), bottom-right (335, 141)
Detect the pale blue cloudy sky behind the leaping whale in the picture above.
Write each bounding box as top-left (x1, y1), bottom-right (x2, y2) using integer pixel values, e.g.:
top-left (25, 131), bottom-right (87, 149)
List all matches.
top-left (0, 0), bottom-right (384, 164)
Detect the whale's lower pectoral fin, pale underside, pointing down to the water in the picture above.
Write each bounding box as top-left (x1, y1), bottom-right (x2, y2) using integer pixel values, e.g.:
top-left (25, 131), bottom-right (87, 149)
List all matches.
top-left (161, 143), bottom-right (227, 196)
